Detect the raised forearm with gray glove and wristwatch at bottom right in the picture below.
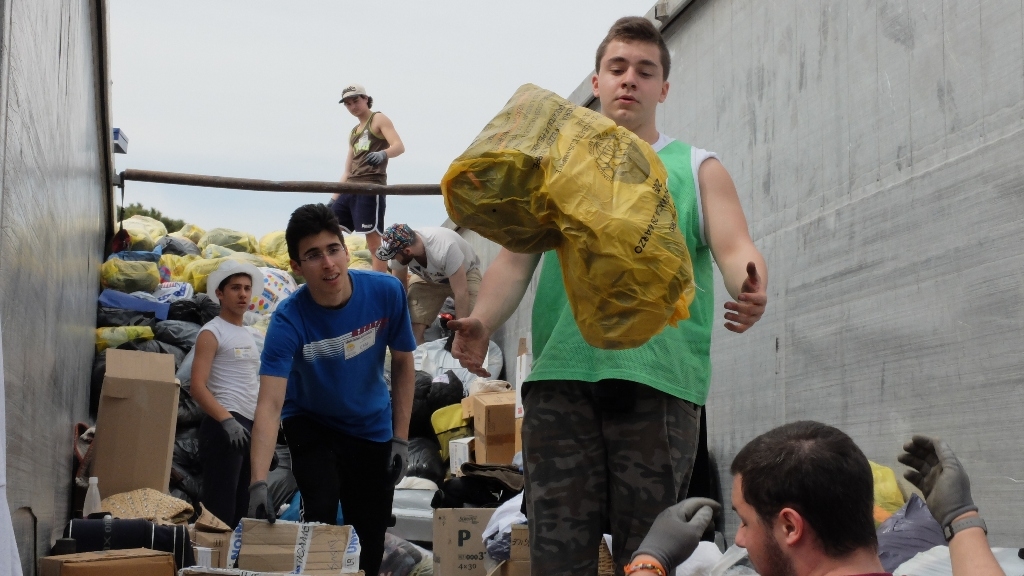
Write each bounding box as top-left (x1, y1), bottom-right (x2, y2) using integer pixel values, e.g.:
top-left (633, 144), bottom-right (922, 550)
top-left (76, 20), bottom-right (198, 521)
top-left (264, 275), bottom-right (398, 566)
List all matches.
top-left (898, 436), bottom-right (1004, 576)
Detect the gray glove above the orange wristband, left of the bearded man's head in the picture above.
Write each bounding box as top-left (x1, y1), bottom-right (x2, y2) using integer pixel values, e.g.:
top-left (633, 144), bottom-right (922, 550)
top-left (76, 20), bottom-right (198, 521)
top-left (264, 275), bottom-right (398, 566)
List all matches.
top-left (633, 498), bottom-right (722, 574)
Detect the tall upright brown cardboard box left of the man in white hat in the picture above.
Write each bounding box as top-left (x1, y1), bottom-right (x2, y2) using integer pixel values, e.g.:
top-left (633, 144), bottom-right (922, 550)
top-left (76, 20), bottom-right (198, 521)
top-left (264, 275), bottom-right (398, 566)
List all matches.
top-left (92, 348), bottom-right (179, 496)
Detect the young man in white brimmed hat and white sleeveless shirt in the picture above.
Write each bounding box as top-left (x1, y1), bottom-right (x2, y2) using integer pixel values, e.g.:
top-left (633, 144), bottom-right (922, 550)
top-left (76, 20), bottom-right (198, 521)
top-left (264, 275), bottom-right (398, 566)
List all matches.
top-left (190, 258), bottom-right (263, 526)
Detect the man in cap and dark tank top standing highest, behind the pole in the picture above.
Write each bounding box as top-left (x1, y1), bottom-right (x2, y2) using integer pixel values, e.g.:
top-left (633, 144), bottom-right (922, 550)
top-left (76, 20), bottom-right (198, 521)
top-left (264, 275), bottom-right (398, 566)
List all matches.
top-left (329, 84), bottom-right (406, 273)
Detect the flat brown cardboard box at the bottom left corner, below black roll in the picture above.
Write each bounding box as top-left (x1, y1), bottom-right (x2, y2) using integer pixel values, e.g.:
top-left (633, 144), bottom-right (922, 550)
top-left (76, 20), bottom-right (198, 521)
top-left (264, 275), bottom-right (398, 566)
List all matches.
top-left (39, 545), bottom-right (174, 576)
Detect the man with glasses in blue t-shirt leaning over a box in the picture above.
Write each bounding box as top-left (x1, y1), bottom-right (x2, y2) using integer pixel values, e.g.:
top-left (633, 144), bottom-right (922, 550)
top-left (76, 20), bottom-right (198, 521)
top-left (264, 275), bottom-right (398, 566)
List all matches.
top-left (249, 204), bottom-right (416, 574)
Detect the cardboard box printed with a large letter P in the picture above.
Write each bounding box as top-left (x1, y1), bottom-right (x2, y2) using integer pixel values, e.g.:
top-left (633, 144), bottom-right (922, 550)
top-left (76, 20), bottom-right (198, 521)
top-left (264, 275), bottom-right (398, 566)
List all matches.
top-left (433, 508), bottom-right (495, 576)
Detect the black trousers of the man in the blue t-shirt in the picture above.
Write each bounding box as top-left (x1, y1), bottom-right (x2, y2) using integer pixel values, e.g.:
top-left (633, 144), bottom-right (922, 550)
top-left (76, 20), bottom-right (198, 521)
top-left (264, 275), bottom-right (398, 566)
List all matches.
top-left (283, 416), bottom-right (394, 574)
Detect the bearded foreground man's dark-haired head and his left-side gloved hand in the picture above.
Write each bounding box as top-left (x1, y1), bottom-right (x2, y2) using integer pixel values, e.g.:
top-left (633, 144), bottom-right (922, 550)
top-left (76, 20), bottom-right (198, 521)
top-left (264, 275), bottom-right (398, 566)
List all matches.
top-left (626, 421), bottom-right (884, 576)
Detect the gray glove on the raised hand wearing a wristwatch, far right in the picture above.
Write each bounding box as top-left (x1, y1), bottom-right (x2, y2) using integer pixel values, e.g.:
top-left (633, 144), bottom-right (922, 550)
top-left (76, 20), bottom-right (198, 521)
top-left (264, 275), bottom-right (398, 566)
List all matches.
top-left (897, 435), bottom-right (978, 531)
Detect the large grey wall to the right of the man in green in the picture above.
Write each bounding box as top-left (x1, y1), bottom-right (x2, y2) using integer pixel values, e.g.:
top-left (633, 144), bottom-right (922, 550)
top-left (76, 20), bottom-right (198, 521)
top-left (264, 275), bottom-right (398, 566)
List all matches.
top-left (574, 0), bottom-right (1024, 546)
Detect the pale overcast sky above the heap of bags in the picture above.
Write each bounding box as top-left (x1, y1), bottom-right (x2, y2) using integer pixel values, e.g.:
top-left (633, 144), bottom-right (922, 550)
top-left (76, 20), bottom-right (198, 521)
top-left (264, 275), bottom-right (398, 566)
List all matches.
top-left (109, 0), bottom-right (653, 238)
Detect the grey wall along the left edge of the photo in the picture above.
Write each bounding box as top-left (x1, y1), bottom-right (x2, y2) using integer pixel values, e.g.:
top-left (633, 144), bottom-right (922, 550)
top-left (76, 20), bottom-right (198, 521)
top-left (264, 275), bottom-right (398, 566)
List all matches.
top-left (0, 0), bottom-right (113, 574)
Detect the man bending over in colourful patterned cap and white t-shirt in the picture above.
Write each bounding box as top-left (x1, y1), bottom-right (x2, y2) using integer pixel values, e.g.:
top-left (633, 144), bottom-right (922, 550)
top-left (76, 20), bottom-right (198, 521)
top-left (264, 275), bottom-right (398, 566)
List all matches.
top-left (377, 224), bottom-right (481, 344)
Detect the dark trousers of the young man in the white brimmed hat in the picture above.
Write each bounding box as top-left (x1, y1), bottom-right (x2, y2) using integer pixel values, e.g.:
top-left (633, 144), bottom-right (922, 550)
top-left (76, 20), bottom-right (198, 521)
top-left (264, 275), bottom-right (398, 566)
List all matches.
top-left (199, 412), bottom-right (253, 528)
